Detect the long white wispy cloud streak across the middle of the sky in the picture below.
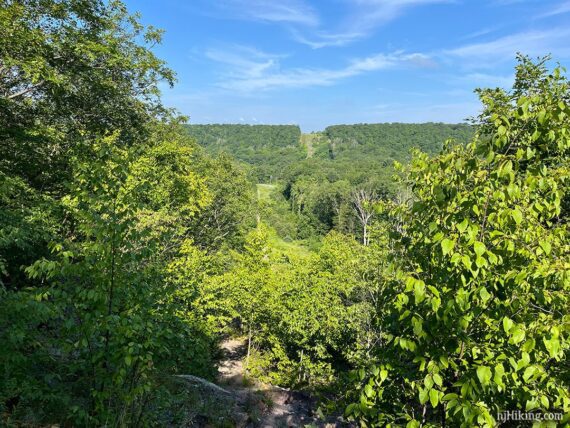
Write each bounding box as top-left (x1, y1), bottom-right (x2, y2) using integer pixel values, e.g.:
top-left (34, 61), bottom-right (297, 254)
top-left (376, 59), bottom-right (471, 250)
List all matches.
top-left (206, 47), bottom-right (434, 93)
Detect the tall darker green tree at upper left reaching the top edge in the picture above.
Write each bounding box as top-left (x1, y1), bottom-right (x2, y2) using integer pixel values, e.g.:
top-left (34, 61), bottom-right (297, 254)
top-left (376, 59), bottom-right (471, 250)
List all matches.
top-left (0, 0), bottom-right (173, 192)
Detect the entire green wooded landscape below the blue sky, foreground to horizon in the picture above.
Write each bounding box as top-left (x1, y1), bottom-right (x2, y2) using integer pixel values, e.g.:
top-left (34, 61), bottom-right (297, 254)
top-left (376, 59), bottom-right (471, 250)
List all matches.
top-left (0, 0), bottom-right (570, 428)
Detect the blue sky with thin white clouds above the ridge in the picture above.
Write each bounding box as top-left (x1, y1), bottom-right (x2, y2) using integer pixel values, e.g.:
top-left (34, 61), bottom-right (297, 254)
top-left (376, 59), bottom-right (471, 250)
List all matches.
top-left (126, 0), bottom-right (570, 132)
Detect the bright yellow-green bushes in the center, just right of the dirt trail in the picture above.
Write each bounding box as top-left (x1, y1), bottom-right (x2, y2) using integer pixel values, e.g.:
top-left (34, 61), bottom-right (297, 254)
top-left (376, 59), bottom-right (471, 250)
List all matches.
top-left (203, 229), bottom-right (368, 389)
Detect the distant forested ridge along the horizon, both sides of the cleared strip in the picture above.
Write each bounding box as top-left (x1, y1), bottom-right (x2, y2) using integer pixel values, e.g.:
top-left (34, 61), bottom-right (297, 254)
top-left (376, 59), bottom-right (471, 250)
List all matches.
top-left (184, 123), bottom-right (474, 187)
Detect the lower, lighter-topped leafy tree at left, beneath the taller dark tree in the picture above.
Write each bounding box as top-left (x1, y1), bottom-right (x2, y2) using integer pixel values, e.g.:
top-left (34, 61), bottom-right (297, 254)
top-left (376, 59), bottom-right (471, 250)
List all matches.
top-left (3, 132), bottom-right (214, 425)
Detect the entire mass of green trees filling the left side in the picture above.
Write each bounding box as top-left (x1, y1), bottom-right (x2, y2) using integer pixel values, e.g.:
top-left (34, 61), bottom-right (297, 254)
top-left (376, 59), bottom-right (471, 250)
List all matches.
top-left (0, 0), bottom-right (224, 426)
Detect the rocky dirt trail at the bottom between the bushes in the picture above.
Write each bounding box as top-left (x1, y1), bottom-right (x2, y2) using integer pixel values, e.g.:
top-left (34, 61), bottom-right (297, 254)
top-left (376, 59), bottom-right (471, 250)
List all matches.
top-left (219, 339), bottom-right (341, 428)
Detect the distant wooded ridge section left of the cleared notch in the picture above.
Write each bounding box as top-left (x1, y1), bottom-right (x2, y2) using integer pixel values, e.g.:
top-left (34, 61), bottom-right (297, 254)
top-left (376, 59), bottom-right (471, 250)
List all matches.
top-left (187, 125), bottom-right (307, 182)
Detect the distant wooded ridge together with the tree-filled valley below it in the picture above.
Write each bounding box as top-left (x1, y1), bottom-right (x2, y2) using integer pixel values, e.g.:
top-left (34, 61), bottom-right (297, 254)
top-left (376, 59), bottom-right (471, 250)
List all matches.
top-left (187, 123), bottom-right (475, 239)
